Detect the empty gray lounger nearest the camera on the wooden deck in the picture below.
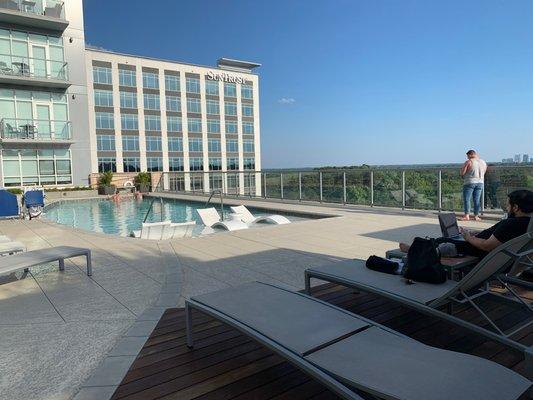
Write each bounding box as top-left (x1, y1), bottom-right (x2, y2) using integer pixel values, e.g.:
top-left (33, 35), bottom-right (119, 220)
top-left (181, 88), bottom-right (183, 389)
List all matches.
top-left (185, 282), bottom-right (531, 400)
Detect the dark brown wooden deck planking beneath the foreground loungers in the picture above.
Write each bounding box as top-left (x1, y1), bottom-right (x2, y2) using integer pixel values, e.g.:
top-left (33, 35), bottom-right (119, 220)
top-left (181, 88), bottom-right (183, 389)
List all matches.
top-left (113, 284), bottom-right (533, 400)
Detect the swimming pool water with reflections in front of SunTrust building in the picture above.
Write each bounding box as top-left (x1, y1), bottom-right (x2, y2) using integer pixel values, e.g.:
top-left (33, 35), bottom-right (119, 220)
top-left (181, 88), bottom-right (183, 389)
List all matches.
top-left (44, 198), bottom-right (308, 236)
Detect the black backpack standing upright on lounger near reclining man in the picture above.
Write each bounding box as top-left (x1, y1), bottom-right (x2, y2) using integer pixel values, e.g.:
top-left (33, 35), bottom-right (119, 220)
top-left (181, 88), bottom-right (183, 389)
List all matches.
top-left (403, 237), bottom-right (447, 283)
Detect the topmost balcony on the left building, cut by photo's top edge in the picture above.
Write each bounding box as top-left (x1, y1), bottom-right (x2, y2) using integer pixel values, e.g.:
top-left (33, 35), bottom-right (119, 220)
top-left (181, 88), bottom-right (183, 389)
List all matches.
top-left (0, 0), bottom-right (68, 32)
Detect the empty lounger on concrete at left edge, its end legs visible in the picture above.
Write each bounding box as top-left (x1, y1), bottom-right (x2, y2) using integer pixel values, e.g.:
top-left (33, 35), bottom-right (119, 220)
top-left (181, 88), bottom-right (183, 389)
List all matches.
top-left (0, 246), bottom-right (92, 276)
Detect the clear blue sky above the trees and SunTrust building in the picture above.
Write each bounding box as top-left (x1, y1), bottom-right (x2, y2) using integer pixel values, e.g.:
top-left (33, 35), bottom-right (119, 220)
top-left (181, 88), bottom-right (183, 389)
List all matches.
top-left (85, 0), bottom-right (533, 168)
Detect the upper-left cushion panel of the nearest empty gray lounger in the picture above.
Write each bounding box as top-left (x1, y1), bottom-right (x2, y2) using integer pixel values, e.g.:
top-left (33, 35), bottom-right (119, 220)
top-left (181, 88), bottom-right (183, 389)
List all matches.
top-left (192, 282), bottom-right (368, 355)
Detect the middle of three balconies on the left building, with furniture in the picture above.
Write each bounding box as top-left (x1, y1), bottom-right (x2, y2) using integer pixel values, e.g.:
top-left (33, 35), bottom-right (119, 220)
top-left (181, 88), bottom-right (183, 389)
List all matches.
top-left (0, 54), bottom-right (70, 89)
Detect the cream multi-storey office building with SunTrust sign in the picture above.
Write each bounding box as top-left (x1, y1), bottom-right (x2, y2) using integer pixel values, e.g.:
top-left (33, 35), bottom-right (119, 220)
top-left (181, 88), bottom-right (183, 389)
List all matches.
top-left (86, 49), bottom-right (261, 192)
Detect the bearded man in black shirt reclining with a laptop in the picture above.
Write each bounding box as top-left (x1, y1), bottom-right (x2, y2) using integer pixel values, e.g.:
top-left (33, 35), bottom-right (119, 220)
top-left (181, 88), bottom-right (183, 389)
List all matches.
top-left (400, 190), bottom-right (533, 258)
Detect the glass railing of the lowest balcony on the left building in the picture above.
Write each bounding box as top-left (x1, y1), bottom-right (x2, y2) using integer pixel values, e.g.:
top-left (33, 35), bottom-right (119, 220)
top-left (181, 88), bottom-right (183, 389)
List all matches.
top-left (0, 118), bottom-right (72, 141)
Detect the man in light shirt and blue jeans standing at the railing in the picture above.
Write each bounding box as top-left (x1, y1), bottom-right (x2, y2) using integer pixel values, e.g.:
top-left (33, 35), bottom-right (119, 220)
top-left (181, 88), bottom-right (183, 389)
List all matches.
top-left (461, 150), bottom-right (487, 221)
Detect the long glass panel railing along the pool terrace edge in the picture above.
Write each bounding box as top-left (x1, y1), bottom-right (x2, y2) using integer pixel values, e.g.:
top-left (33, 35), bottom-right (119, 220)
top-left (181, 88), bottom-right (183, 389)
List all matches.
top-left (153, 164), bottom-right (533, 213)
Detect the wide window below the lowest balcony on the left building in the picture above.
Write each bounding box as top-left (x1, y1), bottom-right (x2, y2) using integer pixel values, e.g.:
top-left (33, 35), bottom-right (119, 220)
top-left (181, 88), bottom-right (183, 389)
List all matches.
top-left (2, 149), bottom-right (72, 186)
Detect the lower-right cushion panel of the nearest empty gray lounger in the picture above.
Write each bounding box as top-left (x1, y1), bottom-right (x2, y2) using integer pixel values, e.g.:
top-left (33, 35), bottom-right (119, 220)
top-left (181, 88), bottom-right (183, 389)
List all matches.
top-left (305, 327), bottom-right (531, 400)
